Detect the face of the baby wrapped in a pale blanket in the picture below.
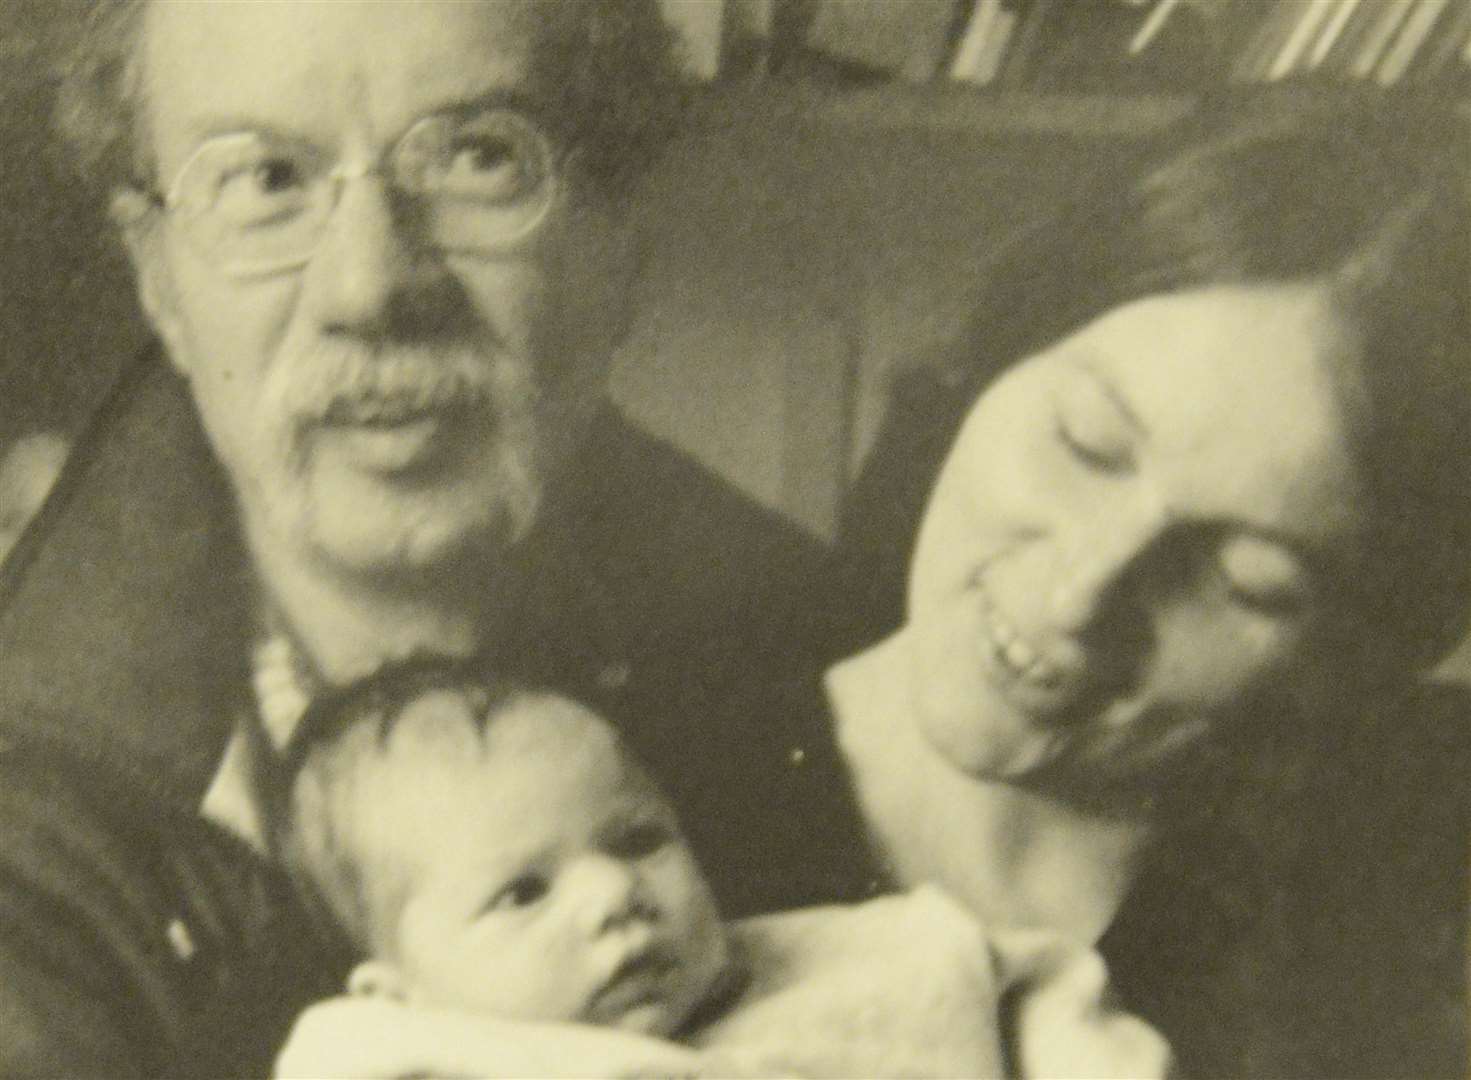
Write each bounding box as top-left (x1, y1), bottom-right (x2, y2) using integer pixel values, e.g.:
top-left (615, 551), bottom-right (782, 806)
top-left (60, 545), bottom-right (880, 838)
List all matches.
top-left (361, 692), bottom-right (727, 1034)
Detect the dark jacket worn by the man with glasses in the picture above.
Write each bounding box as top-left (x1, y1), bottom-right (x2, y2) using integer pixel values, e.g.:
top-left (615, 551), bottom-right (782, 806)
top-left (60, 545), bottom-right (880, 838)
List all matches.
top-left (0, 353), bottom-right (868, 1077)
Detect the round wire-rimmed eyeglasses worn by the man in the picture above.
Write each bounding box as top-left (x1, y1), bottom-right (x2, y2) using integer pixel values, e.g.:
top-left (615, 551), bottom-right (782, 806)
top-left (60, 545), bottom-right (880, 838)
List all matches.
top-left (144, 109), bottom-right (558, 278)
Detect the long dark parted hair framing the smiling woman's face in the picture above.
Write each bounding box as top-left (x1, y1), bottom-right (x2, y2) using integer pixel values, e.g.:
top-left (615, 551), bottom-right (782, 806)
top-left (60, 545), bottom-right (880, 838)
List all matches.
top-left (840, 90), bottom-right (1471, 671)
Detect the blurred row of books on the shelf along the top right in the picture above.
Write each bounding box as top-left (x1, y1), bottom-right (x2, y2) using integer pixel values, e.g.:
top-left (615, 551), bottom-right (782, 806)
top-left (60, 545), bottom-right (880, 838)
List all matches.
top-left (662, 0), bottom-right (1471, 97)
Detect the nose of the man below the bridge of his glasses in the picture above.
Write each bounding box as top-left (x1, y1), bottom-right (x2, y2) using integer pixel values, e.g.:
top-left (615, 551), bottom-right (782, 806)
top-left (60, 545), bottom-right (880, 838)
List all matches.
top-left (304, 175), bottom-right (432, 331)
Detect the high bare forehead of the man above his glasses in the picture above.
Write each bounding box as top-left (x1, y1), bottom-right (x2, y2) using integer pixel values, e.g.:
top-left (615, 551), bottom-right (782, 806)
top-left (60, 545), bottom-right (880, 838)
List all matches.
top-left (143, 0), bottom-right (560, 159)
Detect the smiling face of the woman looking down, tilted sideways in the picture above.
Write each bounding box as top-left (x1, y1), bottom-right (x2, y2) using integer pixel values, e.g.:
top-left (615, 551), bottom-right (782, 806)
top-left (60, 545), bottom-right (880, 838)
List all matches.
top-left (909, 285), bottom-right (1362, 800)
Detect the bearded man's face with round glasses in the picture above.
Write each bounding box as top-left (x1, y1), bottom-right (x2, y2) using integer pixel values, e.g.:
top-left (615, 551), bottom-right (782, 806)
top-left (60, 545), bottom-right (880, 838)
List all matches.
top-left (129, 0), bottom-right (631, 574)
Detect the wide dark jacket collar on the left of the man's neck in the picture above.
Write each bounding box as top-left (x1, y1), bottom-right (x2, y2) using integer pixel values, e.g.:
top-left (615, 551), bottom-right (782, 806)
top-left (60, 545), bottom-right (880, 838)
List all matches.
top-left (0, 350), bottom-right (250, 802)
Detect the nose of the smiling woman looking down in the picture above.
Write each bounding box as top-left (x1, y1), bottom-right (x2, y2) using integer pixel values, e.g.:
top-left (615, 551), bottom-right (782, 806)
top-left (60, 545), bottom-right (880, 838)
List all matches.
top-left (1046, 503), bottom-right (1168, 634)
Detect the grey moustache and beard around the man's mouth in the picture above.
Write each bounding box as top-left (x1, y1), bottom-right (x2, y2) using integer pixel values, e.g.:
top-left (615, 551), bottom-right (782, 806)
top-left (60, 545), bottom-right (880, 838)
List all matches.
top-left (256, 337), bottom-right (546, 571)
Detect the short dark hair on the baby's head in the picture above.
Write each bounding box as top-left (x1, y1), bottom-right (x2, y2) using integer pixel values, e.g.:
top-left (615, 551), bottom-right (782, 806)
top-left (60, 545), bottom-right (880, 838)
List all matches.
top-left (260, 655), bottom-right (556, 955)
